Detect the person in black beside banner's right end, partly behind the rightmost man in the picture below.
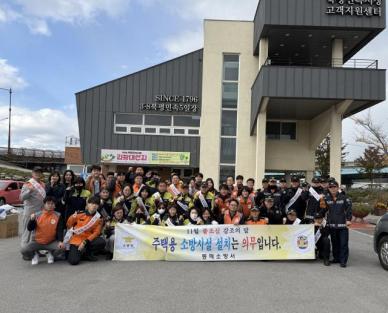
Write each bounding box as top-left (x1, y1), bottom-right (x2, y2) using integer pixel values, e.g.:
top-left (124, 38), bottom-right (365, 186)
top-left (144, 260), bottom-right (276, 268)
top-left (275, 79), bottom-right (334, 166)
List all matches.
top-left (314, 213), bottom-right (330, 266)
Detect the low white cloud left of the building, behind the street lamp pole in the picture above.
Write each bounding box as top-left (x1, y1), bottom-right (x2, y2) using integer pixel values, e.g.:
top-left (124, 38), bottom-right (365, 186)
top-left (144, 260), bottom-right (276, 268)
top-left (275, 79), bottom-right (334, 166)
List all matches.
top-left (0, 105), bottom-right (78, 150)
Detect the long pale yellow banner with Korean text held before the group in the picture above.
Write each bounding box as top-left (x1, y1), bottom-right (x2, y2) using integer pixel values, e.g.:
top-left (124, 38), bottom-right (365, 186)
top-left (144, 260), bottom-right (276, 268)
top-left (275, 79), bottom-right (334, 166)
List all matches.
top-left (114, 224), bottom-right (315, 261)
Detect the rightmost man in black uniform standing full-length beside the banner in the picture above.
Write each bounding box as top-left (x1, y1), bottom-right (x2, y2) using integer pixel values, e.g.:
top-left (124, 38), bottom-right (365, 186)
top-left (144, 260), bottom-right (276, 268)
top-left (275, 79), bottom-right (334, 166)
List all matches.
top-left (320, 181), bottom-right (352, 267)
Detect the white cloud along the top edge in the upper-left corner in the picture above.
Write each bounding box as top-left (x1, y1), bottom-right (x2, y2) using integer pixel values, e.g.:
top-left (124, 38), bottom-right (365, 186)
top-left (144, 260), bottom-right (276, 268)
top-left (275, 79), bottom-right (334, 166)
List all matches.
top-left (0, 0), bottom-right (130, 36)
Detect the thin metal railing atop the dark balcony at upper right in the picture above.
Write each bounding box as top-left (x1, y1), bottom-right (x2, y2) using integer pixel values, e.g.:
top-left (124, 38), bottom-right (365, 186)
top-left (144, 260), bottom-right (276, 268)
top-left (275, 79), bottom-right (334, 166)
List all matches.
top-left (264, 57), bottom-right (379, 69)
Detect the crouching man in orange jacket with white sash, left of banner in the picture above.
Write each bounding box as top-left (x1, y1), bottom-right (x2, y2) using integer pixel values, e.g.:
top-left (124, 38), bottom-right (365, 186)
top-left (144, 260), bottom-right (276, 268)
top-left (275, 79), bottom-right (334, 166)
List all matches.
top-left (65, 196), bottom-right (105, 265)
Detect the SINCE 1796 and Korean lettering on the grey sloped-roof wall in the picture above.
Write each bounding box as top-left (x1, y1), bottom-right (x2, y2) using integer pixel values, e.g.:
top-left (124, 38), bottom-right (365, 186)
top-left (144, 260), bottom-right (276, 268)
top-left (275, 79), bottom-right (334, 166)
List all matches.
top-left (140, 95), bottom-right (200, 113)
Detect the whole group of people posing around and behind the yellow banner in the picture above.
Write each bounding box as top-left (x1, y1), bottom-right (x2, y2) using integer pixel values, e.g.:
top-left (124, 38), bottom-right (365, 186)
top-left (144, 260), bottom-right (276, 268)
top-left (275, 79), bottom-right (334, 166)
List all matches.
top-left (20, 165), bottom-right (352, 267)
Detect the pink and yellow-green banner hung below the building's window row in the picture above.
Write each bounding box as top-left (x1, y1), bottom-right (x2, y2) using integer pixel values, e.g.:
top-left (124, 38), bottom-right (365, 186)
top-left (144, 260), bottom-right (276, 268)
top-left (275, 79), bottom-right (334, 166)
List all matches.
top-left (101, 149), bottom-right (190, 165)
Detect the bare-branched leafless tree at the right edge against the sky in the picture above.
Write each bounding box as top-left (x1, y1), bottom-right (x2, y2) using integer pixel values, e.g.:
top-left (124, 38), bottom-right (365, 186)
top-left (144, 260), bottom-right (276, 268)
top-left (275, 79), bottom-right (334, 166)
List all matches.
top-left (351, 110), bottom-right (388, 157)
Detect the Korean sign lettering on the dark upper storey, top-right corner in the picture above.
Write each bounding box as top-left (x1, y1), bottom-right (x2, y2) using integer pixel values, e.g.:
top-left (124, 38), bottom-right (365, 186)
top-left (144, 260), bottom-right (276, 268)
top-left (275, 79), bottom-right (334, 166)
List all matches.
top-left (326, 0), bottom-right (382, 17)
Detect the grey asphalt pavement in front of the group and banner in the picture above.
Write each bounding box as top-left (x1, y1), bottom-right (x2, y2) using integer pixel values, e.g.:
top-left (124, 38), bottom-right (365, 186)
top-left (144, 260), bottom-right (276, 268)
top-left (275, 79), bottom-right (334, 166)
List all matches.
top-left (0, 231), bottom-right (388, 313)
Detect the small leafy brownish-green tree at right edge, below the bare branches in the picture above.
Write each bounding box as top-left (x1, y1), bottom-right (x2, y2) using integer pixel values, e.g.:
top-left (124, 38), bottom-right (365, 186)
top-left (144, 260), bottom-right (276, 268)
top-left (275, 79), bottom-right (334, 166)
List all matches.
top-left (355, 146), bottom-right (384, 184)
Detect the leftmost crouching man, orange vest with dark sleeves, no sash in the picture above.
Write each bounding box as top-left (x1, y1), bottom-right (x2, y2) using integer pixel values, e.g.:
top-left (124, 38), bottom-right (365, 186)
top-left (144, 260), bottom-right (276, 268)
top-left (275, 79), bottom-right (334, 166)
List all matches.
top-left (21, 196), bottom-right (65, 265)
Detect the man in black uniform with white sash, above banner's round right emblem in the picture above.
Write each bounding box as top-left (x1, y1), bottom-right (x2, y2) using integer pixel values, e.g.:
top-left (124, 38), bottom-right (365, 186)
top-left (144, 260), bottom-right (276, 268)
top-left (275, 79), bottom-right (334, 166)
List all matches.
top-left (283, 176), bottom-right (309, 220)
